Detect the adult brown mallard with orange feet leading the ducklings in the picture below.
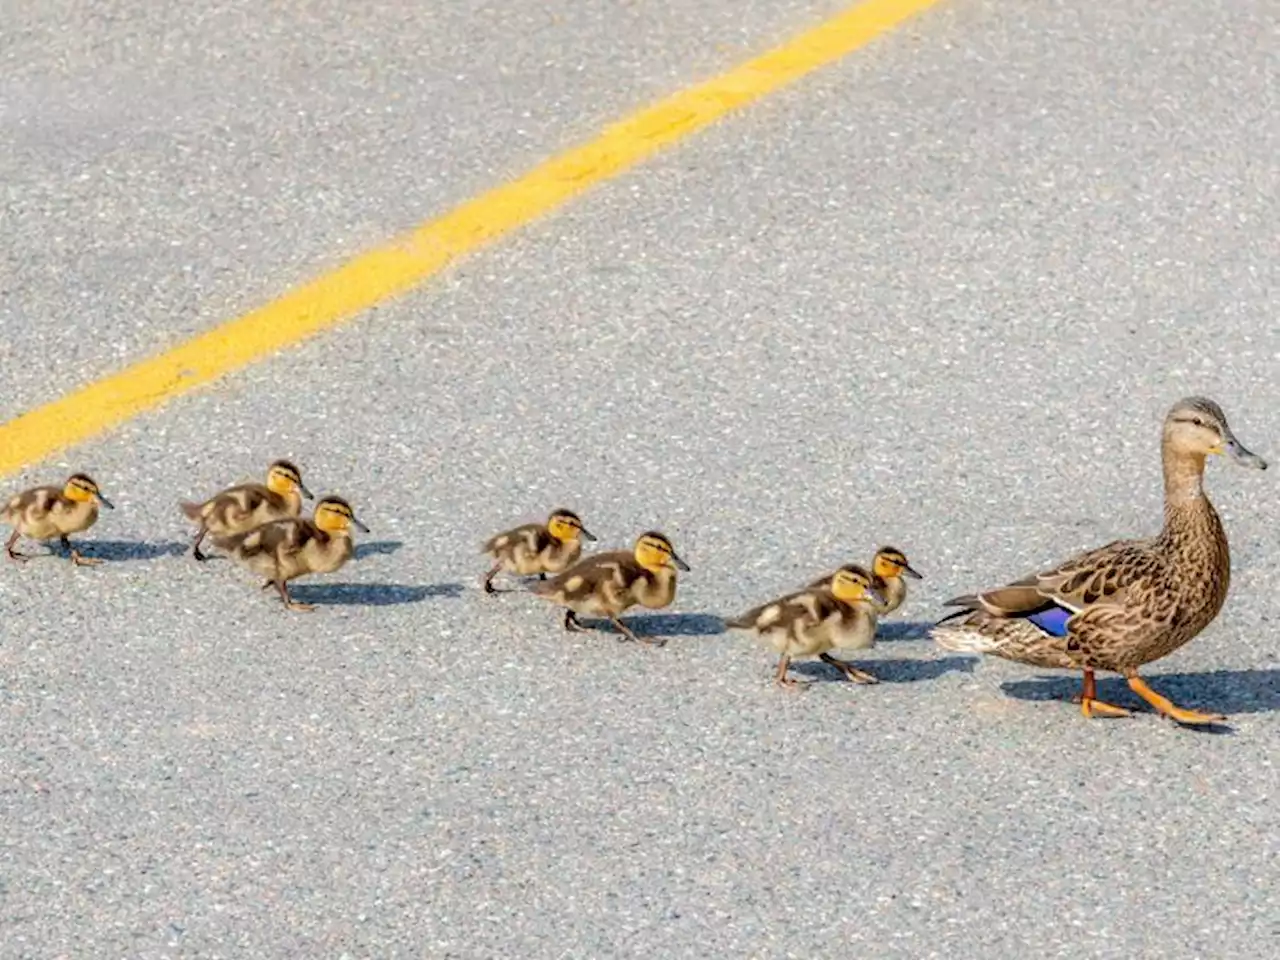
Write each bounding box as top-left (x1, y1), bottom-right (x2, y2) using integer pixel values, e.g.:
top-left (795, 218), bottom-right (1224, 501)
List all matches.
top-left (933, 397), bottom-right (1267, 723)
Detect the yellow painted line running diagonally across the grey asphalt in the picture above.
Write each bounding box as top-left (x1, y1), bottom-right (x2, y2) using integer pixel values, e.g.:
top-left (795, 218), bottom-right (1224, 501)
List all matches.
top-left (0, 0), bottom-right (940, 475)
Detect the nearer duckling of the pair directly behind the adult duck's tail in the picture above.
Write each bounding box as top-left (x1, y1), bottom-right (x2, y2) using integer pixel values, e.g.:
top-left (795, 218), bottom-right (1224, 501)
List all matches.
top-left (724, 563), bottom-right (886, 689)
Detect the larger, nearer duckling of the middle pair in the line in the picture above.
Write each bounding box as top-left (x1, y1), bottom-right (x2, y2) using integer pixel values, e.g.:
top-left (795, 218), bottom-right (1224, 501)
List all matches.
top-left (534, 530), bottom-right (689, 646)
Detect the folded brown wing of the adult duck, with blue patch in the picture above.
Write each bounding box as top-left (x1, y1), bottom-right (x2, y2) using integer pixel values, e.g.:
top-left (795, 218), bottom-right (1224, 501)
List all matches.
top-left (943, 540), bottom-right (1161, 636)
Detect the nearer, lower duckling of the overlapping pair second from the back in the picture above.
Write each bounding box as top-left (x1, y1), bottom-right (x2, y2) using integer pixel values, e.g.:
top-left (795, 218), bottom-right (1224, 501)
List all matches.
top-left (214, 497), bottom-right (369, 611)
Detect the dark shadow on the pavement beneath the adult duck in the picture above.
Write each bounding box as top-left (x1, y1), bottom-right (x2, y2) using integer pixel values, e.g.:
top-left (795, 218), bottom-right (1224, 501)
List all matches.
top-left (1001, 669), bottom-right (1280, 731)
